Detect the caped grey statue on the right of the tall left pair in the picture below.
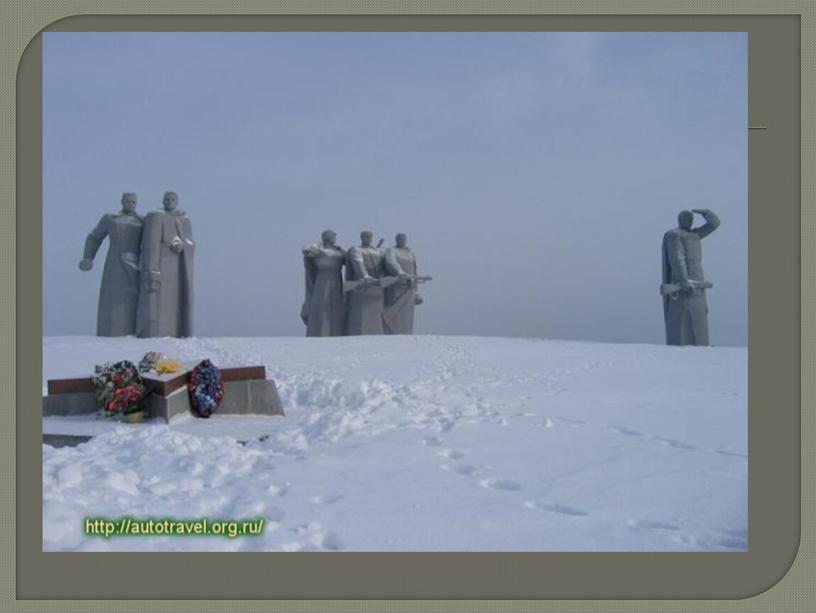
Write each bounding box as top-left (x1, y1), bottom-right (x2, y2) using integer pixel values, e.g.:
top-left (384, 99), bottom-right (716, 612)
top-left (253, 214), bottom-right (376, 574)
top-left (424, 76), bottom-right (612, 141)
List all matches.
top-left (136, 192), bottom-right (195, 338)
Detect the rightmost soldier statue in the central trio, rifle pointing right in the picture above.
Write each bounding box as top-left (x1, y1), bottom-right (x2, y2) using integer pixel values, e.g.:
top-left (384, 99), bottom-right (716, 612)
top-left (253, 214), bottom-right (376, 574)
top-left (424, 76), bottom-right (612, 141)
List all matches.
top-left (383, 234), bottom-right (430, 334)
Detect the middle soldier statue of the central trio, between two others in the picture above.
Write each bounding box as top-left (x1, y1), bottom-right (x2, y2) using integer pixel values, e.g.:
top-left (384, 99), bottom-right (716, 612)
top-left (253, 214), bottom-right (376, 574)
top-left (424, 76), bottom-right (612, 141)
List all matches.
top-left (344, 230), bottom-right (384, 335)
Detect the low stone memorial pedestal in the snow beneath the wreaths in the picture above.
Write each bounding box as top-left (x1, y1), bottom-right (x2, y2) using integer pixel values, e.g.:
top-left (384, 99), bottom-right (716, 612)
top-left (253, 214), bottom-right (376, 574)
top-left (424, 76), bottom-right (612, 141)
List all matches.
top-left (43, 364), bottom-right (284, 422)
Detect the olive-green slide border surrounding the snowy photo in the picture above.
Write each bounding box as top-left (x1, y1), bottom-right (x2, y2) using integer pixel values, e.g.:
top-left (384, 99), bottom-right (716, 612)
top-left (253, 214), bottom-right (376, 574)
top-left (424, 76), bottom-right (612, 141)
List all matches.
top-left (0, 0), bottom-right (815, 611)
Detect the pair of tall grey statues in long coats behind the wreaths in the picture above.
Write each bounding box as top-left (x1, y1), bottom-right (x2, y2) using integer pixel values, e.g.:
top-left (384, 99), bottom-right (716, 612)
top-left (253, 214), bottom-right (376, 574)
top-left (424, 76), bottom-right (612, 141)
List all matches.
top-left (79, 192), bottom-right (195, 338)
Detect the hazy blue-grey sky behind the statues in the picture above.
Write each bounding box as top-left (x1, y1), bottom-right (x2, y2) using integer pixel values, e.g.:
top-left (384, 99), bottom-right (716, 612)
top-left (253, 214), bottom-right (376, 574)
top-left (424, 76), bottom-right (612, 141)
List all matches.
top-left (43, 32), bottom-right (748, 345)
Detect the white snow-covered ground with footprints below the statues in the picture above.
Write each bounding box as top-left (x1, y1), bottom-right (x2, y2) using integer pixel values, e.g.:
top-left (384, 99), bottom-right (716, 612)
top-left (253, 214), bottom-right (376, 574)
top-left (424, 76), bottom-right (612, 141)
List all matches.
top-left (43, 336), bottom-right (748, 551)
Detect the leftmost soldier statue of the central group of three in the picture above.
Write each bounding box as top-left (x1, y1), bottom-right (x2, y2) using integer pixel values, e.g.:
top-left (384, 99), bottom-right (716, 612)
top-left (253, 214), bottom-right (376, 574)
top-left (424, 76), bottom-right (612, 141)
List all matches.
top-left (300, 230), bottom-right (346, 336)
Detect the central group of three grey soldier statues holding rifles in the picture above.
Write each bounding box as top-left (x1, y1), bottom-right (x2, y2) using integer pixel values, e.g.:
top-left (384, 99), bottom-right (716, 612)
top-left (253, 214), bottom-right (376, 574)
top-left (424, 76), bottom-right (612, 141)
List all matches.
top-left (300, 230), bottom-right (430, 336)
